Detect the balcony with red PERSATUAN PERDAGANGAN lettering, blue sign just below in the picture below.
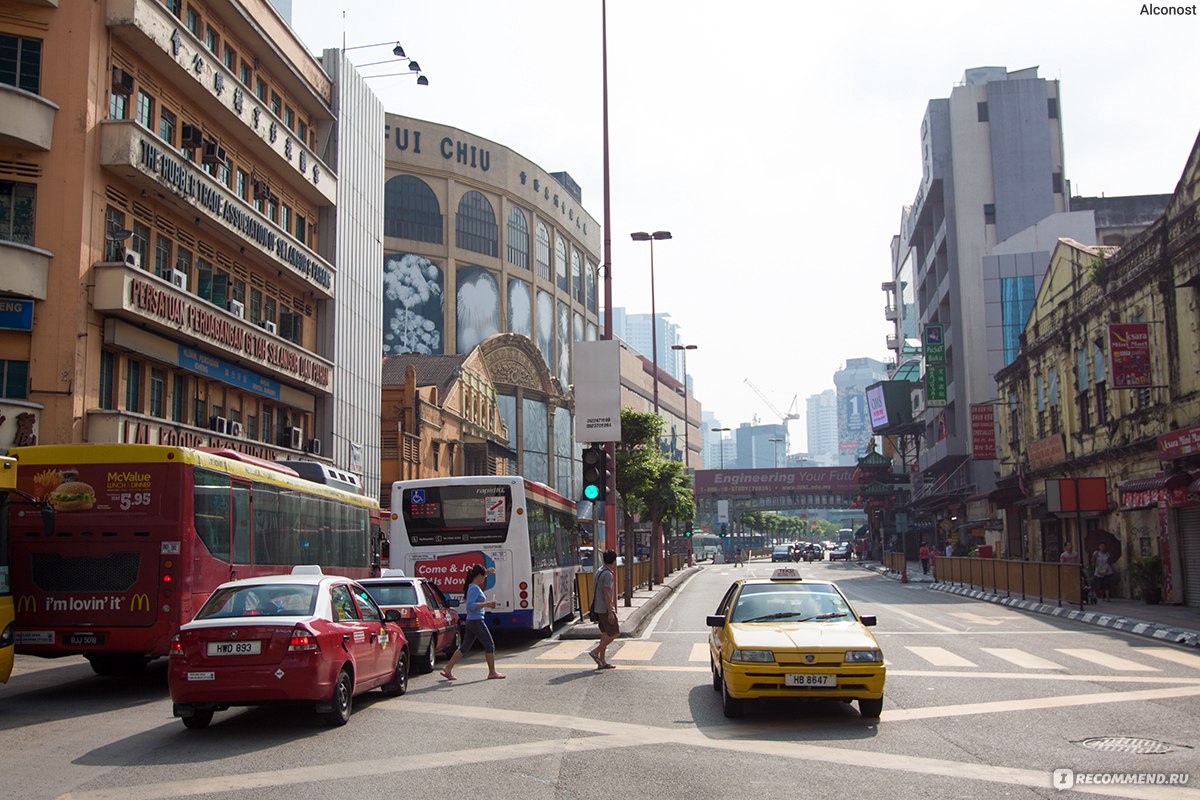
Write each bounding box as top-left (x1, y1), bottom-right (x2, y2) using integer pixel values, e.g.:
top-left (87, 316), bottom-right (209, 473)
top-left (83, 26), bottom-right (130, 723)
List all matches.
top-left (92, 263), bottom-right (334, 405)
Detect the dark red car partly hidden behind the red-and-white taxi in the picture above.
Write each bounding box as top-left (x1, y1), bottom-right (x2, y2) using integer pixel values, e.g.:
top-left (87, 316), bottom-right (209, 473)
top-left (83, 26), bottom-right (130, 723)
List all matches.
top-left (359, 570), bottom-right (462, 672)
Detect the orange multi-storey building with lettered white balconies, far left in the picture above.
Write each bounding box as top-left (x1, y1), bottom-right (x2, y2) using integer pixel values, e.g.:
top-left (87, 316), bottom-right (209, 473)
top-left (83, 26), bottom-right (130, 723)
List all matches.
top-left (0, 0), bottom-right (364, 458)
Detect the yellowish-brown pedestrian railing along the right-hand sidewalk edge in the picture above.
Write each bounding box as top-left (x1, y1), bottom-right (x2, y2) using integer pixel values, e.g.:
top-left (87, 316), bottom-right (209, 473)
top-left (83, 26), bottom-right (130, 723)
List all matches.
top-left (931, 553), bottom-right (1080, 606)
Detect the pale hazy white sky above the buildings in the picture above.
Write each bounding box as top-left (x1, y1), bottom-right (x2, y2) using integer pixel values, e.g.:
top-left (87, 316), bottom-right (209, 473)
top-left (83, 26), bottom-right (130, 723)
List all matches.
top-left (293, 0), bottom-right (1200, 452)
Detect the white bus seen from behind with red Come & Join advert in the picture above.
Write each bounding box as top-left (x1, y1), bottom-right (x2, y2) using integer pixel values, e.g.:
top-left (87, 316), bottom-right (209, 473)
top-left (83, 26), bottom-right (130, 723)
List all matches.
top-left (390, 475), bottom-right (580, 636)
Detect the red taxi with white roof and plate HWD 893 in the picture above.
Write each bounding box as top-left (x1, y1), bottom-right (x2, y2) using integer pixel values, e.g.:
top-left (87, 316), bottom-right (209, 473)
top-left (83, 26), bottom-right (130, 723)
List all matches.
top-left (167, 567), bottom-right (408, 728)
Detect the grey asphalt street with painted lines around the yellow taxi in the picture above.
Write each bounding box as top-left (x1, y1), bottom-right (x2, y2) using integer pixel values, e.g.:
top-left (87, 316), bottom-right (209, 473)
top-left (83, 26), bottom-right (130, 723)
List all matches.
top-left (0, 561), bottom-right (1200, 800)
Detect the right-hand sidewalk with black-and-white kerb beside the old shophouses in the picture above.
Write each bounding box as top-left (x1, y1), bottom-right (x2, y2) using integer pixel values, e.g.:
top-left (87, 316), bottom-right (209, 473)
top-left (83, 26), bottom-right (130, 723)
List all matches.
top-left (859, 561), bottom-right (1200, 648)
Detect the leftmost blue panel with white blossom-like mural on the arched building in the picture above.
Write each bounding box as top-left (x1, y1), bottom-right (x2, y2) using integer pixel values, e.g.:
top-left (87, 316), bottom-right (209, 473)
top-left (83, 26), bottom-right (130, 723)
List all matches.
top-left (383, 253), bottom-right (445, 354)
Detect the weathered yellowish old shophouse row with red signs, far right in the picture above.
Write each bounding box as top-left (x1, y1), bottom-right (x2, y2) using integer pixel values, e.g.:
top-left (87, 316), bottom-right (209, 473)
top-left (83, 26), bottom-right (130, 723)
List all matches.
top-left (994, 134), bottom-right (1200, 607)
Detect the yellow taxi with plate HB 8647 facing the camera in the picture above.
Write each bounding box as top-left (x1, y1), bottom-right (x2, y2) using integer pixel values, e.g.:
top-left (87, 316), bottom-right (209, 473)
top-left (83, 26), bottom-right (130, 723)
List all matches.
top-left (706, 567), bottom-right (887, 718)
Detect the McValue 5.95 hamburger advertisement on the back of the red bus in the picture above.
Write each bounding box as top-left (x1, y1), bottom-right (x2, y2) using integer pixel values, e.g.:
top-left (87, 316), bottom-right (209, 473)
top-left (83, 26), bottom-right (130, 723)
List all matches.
top-left (32, 464), bottom-right (161, 513)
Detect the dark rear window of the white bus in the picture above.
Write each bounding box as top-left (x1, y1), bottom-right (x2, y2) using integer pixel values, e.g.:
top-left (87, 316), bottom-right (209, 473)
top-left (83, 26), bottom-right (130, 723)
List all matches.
top-left (401, 486), bottom-right (512, 546)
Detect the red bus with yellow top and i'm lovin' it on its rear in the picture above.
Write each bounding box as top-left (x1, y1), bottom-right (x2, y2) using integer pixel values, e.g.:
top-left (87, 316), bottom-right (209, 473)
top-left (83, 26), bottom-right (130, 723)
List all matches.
top-left (8, 444), bottom-right (380, 675)
